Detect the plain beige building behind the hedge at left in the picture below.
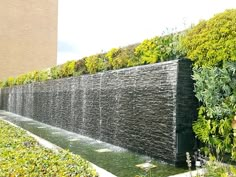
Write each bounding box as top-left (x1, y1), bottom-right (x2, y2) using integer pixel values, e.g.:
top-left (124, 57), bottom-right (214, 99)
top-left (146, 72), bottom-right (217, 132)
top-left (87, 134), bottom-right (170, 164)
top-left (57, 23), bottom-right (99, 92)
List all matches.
top-left (0, 0), bottom-right (58, 80)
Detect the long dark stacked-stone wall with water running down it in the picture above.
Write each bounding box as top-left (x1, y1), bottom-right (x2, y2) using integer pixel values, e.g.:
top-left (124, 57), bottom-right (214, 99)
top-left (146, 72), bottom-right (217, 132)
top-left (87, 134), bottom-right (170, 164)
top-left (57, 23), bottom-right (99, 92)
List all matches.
top-left (0, 59), bottom-right (197, 164)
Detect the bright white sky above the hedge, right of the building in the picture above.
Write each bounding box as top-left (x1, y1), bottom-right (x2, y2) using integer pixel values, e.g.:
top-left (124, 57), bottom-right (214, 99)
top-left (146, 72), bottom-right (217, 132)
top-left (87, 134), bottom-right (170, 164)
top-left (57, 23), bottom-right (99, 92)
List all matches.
top-left (57, 0), bottom-right (236, 64)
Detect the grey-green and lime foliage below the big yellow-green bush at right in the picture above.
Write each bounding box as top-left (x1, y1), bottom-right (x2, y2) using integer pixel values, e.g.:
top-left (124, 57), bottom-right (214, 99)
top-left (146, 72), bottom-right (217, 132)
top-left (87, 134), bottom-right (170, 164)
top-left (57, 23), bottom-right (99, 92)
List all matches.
top-left (193, 62), bottom-right (236, 160)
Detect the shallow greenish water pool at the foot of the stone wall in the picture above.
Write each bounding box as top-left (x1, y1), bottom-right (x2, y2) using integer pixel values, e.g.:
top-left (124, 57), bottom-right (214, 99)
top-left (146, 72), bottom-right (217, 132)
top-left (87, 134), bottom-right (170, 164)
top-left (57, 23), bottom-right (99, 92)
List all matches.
top-left (0, 111), bottom-right (186, 177)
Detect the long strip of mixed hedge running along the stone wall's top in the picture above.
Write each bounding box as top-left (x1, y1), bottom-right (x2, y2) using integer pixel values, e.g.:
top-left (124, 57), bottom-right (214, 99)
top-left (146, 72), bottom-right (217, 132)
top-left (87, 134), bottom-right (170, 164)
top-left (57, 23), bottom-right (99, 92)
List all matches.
top-left (0, 34), bottom-right (183, 88)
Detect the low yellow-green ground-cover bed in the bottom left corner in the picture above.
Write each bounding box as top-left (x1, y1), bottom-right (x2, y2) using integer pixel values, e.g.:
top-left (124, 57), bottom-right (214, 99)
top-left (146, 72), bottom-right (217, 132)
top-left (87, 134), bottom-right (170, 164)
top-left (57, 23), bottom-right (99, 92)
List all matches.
top-left (0, 121), bottom-right (97, 177)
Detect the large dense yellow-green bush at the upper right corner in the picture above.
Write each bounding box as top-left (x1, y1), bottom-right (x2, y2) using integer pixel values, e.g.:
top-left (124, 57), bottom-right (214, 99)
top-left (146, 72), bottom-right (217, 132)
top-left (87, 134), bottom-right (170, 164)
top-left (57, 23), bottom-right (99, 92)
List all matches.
top-left (181, 9), bottom-right (236, 66)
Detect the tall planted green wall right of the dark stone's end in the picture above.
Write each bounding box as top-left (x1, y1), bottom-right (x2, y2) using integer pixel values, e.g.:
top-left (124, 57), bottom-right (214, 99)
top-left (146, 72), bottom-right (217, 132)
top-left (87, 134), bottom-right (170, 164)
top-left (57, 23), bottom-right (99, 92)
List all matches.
top-left (187, 9), bottom-right (236, 160)
